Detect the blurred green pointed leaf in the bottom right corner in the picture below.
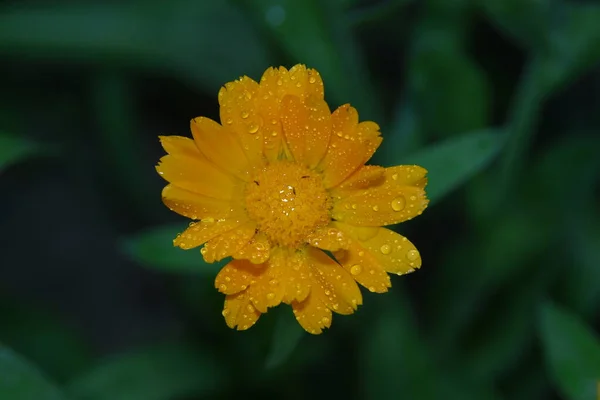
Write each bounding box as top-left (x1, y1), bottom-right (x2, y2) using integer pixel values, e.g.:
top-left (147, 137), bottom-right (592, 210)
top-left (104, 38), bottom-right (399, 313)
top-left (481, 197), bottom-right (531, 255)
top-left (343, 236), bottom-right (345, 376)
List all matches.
top-left (540, 303), bottom-right (600, 400)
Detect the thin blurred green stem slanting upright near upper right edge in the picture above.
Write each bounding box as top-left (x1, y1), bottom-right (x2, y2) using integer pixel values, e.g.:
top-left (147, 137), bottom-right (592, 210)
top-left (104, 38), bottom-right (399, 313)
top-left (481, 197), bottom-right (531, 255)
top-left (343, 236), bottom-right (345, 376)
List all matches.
top-left (498, 56), bottom-right (545, 205)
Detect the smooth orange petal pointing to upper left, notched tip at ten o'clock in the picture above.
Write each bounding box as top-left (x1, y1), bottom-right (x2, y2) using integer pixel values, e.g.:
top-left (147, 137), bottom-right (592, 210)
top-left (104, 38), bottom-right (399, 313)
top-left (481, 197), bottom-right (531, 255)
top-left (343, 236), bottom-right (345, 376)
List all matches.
top-left (190, 117), bottom-right (250, 181)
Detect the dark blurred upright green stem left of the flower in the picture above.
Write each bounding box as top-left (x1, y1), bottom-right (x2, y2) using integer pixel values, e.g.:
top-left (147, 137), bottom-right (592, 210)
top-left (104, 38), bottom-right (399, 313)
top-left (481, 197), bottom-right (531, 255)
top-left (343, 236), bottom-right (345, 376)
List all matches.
top-left (92, 70), bottom-right (158, 219)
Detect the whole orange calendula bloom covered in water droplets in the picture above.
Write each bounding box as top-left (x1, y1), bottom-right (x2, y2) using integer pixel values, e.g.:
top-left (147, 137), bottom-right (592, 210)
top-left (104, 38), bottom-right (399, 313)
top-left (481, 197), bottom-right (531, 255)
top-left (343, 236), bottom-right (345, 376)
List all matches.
top-left (157, 65), bottom-right (428, 334)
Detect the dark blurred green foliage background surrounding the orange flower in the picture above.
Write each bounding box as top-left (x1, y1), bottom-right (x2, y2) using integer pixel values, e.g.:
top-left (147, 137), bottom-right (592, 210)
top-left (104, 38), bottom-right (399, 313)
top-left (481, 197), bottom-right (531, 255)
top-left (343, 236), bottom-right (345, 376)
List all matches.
top-left (0, 0), bottom-right (600, 400)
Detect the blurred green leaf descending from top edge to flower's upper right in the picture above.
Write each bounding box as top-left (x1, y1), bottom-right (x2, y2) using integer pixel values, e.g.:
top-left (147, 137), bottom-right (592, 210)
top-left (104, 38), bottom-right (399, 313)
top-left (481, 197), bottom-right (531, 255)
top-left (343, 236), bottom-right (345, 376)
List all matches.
top-left (245, 0), bottom-right (382, 121)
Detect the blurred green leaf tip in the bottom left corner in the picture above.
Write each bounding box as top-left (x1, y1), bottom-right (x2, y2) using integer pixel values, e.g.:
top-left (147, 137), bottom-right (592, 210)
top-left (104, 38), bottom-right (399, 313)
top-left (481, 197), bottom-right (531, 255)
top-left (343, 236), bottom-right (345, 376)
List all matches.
top-left (0, 344), bottom-right (65, 400)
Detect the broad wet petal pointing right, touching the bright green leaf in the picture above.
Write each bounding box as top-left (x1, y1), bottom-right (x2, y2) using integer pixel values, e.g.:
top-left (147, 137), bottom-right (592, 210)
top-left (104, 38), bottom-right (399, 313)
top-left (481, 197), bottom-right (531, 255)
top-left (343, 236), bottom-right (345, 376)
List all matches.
top-left (332, 165), bottom-right (429, 226)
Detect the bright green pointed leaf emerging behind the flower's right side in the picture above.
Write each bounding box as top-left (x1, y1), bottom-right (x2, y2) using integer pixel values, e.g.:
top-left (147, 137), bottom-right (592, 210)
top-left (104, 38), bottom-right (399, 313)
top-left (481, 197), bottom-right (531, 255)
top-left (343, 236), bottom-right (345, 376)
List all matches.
top-left (402, 130), bottom-right (504, 203)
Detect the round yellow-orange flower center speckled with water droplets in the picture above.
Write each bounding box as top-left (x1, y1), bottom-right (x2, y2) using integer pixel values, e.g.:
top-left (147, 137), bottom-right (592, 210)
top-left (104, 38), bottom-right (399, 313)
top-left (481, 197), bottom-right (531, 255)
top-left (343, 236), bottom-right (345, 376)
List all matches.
top-left (246, 161), bottom-right (331, 248)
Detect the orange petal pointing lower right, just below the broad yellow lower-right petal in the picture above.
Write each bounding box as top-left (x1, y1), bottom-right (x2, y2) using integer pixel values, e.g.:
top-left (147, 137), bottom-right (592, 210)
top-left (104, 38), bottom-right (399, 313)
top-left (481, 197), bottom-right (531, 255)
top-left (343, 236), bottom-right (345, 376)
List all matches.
top-left (333, 230), bottom-right (392, 293)
